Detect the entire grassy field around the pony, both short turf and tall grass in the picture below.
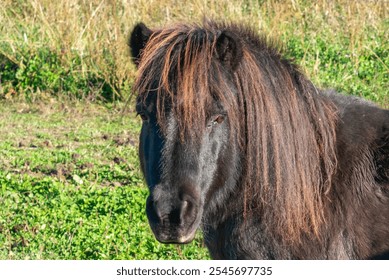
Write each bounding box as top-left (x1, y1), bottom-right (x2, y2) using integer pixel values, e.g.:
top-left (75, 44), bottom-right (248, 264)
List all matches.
top-left (0, 0), bottom-right (389, 259)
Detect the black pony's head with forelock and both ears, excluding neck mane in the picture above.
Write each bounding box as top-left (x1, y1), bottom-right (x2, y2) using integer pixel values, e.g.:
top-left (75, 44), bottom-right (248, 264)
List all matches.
top-left (130, 21), bottom-right (242, 243)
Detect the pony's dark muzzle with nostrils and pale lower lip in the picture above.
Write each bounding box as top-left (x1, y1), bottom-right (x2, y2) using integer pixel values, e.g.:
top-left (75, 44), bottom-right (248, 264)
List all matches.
top-left (146, 187), bottom-right (201, 243)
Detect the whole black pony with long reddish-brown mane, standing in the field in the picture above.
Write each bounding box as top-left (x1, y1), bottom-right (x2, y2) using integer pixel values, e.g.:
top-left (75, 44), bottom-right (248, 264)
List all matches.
top-left (128, 20), bottom-right (389, 259)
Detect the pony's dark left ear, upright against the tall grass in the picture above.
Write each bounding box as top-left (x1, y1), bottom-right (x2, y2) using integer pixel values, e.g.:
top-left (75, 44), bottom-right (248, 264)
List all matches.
top-left (128, 22), bottom-right (153, 66)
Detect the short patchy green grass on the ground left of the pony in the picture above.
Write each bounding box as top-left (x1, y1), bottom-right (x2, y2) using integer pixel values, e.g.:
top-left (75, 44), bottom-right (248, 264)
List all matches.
top-left (0, 102), bottom-right (208, 259)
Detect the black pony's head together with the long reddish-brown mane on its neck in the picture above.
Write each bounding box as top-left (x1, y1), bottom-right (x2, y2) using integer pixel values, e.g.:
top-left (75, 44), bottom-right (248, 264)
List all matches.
top-left (129, 22), bottom-right (336, 243)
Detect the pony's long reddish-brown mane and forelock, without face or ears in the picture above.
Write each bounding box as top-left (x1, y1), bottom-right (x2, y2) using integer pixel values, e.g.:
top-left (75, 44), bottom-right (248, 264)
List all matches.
top-left (134, 22), bottom-right (337, 244)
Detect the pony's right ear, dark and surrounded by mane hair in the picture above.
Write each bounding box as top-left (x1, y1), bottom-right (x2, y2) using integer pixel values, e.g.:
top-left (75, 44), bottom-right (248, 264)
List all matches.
top-left (216, 31), bottom-right (243, 71)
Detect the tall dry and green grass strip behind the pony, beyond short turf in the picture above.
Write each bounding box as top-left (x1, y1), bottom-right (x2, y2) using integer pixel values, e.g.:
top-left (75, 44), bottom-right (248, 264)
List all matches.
top-left (0, 0), bottom-right (389, 105)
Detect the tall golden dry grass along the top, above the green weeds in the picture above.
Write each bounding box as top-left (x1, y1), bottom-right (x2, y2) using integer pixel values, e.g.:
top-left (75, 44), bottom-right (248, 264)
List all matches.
top-left (0, 0), bottom-right (389, 100)
